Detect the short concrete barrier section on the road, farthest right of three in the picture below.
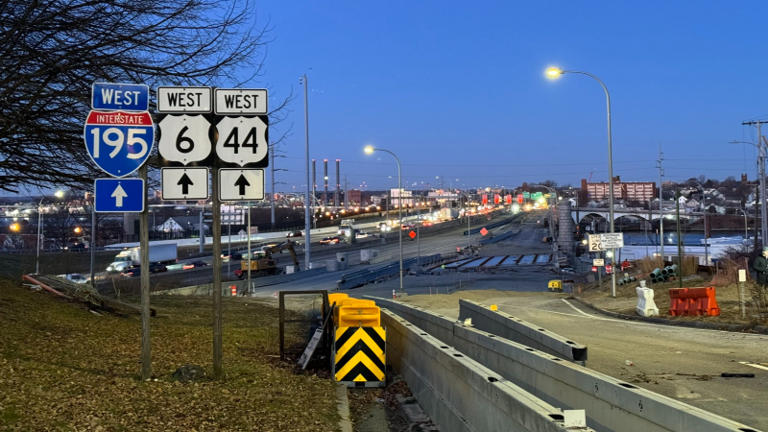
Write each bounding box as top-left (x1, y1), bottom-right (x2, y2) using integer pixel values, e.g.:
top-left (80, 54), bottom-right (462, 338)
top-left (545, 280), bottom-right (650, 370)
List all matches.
top-left (459, 299), bottom-right (587, 366)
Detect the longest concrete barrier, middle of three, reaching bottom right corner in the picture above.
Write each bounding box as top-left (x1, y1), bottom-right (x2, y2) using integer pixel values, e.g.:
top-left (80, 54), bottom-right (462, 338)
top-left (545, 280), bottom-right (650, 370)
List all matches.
top-left (366, 296), bottom-right (759, 432)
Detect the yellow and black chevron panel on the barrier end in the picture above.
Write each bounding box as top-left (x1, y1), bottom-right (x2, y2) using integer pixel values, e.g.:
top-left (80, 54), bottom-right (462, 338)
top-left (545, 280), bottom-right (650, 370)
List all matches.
top-left (333, 326), bottom-right (386, 387)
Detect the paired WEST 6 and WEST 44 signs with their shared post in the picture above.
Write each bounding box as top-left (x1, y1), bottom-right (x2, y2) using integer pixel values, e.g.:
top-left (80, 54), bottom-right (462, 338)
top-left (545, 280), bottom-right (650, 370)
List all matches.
top-left (152, 83), bottom-right (269, 378)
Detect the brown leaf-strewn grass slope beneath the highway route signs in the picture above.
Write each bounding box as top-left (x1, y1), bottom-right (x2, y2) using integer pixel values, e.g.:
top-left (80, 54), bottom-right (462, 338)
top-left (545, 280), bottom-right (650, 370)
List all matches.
top-left (0, 279), bottom-right (338, 431)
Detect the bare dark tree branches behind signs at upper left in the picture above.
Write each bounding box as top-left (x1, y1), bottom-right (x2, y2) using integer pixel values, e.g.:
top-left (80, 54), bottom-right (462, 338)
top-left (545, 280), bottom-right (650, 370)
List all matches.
top-left (0, 0), bottom-right (266, 192)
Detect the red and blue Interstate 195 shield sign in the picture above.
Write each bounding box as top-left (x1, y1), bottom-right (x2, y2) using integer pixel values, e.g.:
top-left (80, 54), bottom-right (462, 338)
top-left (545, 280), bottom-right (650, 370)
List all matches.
top-left (84, 111), bottom-right (155, 177)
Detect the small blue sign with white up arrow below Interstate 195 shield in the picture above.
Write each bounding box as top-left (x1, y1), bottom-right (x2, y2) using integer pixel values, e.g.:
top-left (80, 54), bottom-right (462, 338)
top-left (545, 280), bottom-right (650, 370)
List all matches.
top-left (93, 178), bottom-right (145, 213)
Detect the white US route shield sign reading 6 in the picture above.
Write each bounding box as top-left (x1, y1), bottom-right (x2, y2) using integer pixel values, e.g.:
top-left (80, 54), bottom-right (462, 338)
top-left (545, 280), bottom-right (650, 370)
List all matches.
top-left (157, 114), bottom-right (211, 165)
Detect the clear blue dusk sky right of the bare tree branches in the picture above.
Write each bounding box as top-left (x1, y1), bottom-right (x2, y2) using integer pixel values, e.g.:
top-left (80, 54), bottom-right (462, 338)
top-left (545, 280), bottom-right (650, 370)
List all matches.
top-left (248, 0), bottom-right (768, 191)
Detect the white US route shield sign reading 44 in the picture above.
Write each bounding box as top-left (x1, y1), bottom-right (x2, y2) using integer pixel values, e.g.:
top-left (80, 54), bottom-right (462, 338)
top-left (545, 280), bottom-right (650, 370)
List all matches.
top-left (216, 117), bottom-right (269, 166)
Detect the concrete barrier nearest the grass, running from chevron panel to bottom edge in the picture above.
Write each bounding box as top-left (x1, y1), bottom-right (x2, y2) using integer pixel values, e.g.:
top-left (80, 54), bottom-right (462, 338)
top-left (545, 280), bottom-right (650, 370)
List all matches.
top-left (382, 309), bottom-right (593, 432)
